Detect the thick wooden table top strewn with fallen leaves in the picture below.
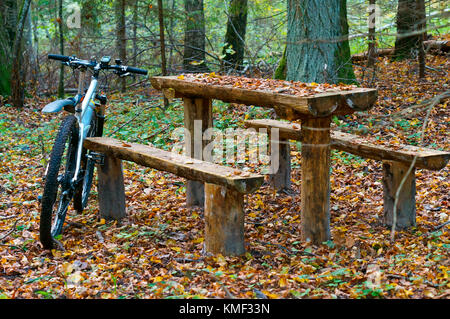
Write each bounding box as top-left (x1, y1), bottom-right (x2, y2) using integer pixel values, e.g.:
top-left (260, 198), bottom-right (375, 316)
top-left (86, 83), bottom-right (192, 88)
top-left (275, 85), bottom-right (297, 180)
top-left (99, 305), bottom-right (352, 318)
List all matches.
top-left (150, 76), bottom-right (377, 120)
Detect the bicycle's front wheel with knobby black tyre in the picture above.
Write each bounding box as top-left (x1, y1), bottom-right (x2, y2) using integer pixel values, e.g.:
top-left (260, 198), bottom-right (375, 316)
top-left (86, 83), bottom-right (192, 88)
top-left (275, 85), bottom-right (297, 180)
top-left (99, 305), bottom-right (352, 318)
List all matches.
top-left (39, 115), bottom-right (79, 249)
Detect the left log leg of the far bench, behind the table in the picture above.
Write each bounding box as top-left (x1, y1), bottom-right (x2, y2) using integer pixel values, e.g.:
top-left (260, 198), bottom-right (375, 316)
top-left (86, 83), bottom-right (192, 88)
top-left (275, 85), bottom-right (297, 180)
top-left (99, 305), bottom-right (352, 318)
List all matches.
top-left (269, 139), bottom-right (291, 191)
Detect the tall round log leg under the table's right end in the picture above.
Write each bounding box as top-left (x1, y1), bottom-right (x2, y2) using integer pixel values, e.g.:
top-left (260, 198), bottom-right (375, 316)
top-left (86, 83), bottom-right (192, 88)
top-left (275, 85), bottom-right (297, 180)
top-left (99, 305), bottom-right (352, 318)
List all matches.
top-left (301, 117), bottom-right (331, 244)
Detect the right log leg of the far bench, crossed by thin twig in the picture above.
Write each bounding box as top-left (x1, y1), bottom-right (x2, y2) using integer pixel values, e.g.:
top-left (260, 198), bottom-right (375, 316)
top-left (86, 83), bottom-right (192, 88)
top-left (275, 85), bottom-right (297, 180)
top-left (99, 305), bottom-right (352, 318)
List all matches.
top-left (383, 161), bottom-right (416, 229)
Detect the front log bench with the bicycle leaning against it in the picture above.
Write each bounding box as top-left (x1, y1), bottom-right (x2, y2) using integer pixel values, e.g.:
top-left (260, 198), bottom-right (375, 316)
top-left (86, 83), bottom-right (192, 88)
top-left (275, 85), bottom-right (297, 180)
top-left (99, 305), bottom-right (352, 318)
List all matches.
top-left (84, 137), bottom-right (264, 255)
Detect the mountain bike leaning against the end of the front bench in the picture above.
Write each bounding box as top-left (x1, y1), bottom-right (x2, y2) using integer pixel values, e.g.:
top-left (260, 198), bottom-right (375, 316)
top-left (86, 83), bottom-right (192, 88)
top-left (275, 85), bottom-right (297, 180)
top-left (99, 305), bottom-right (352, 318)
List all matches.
top-left (39, 54), bottom-right (147, 249)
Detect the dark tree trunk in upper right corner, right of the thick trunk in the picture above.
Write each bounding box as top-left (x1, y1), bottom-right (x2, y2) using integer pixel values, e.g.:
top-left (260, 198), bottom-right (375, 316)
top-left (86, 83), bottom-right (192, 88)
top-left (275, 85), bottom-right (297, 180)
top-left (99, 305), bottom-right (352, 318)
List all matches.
top-left (394, 0), bottom-right (418, 60)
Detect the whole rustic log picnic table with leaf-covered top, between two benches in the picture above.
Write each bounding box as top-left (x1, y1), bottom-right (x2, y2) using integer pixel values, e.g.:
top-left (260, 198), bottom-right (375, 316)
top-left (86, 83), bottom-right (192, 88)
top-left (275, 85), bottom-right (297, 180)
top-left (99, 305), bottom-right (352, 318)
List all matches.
top-left (150, 76), bottom-right (377, 244)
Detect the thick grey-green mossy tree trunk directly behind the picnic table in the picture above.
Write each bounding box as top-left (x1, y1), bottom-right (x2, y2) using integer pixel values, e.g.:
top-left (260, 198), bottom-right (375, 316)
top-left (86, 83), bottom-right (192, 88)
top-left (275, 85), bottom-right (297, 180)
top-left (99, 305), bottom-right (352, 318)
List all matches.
top-left (286, 0), bottom-right (356, 83)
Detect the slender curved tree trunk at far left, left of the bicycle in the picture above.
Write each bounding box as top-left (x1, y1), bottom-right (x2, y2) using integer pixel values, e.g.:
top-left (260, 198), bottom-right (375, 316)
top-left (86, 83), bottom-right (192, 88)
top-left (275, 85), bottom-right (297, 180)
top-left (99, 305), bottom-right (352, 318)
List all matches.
top-left (11, 0), bottom-right (31, 107)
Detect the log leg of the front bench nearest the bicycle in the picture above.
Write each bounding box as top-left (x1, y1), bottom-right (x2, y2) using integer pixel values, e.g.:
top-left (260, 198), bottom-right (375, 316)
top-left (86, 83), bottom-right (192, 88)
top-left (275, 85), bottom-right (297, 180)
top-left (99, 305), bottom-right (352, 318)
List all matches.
top-left (97, 155), bottom-right (126, 220)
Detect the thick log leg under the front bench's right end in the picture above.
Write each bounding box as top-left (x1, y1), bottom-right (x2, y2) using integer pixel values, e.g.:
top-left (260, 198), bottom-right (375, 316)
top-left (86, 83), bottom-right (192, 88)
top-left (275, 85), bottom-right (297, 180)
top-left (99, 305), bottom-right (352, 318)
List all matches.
top-left (205, 183), bottom-right (245, 256)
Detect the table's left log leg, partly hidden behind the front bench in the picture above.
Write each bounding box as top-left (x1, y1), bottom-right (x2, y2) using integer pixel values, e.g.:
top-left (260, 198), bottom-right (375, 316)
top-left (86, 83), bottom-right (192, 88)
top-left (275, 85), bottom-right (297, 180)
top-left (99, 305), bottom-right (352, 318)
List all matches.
top-left (183, 97), bottom-right (212, 207)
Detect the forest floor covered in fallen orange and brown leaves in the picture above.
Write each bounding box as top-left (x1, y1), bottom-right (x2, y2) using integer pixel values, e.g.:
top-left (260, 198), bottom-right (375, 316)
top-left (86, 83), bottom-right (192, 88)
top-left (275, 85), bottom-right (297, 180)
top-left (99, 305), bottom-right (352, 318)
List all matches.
top-left (0, 56), bottom-right (450, 298)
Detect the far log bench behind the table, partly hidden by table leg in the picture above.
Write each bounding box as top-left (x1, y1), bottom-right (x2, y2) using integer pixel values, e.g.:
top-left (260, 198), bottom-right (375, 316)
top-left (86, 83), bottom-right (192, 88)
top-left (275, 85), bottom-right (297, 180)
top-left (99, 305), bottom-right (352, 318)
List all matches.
top-left (244, 120), bottom-right (450, 228)
